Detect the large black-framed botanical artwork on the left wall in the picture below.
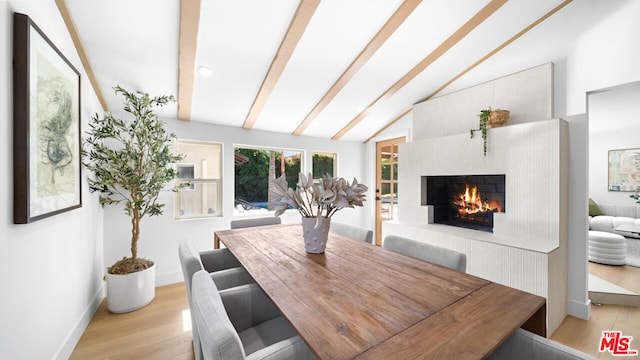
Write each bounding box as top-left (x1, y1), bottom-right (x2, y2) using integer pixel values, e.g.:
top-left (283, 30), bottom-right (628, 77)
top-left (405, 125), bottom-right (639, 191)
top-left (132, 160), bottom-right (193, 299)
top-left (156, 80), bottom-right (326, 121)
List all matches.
top-left (13, 13), bottom-right (82, 224)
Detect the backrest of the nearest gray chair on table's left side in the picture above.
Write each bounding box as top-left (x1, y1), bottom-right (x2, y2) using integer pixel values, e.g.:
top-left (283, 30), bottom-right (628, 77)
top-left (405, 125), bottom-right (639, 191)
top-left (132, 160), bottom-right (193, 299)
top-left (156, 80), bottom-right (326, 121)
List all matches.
top-left (191, 270), bottom-right (245, 360)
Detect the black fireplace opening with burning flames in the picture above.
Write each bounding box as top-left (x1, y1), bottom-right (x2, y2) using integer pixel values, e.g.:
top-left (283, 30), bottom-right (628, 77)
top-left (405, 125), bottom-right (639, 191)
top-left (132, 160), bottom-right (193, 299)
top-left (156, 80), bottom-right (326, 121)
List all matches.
top-left (422, 175), bottom-right (505, 232)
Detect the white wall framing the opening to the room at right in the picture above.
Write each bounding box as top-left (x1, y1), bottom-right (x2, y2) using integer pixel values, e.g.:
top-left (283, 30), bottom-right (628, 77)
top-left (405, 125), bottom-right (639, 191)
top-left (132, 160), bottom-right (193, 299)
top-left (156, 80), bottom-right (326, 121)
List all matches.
top-left (555, 0), bottom-right (640, 318)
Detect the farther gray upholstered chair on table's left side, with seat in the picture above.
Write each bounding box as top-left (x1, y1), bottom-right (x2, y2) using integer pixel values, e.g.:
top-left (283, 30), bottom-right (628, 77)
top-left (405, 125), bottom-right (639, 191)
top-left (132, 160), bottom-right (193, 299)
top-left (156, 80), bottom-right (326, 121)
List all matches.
top-left (178, 238), bottom-right (254, 360)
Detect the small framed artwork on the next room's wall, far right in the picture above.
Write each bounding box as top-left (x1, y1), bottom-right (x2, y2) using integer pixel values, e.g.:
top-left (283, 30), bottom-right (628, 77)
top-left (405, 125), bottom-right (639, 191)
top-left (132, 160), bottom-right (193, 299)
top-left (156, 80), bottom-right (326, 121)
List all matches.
top-left (608, 149), bottom-right (640, 192)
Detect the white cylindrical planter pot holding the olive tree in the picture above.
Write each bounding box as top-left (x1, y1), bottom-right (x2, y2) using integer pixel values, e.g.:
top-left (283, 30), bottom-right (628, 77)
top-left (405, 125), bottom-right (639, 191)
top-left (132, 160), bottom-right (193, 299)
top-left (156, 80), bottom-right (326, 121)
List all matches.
top-left (107, 264), bottom-right (156, 313)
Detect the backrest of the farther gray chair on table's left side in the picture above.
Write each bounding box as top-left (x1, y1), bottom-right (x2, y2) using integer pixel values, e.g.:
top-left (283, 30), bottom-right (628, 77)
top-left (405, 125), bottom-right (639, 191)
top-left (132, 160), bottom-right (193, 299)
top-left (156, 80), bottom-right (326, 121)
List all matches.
top-left (178, 238), bottom-right (206, 360)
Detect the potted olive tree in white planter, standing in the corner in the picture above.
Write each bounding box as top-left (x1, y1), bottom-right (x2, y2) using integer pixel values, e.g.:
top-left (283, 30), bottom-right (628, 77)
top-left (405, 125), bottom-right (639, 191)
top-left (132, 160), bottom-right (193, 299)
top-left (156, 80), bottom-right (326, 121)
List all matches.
top-left (82, 86), bottom-right (182, 312)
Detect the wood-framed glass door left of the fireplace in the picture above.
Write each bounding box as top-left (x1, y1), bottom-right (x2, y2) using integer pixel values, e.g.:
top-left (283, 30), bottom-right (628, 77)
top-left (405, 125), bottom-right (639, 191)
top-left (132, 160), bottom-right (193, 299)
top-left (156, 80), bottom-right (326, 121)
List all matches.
top-left (376, 137), bottom-right (405, 246)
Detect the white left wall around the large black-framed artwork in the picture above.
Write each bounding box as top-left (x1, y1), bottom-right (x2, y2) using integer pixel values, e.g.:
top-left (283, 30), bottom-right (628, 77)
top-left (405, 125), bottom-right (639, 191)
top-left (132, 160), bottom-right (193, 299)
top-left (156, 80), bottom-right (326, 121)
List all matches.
top-left (0, 1), bottom-right (103, 359)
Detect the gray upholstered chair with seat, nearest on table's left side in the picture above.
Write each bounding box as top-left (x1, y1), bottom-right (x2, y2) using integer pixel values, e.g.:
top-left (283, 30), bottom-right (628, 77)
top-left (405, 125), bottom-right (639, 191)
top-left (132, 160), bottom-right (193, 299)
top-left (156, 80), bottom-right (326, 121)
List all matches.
top-left (191, 271), bottom-right (315, 360)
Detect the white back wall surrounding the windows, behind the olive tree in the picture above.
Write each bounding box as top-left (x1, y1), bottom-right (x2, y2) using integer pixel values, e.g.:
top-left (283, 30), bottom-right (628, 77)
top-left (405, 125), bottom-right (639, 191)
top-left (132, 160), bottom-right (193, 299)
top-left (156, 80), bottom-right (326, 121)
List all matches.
top-left (104, 119), bottom-right (374, 286)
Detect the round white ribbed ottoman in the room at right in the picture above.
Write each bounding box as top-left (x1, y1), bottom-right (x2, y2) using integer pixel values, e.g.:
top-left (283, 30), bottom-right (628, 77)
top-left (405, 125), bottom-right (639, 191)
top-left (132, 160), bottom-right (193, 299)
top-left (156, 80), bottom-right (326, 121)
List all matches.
top-left (588, 230), bottom-right (627, 265)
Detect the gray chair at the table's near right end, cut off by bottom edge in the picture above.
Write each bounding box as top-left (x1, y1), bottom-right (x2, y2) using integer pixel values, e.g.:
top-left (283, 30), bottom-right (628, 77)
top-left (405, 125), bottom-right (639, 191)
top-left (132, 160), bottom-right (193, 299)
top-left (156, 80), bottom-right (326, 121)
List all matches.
top-left (487, 329), bottom-right (595, 360)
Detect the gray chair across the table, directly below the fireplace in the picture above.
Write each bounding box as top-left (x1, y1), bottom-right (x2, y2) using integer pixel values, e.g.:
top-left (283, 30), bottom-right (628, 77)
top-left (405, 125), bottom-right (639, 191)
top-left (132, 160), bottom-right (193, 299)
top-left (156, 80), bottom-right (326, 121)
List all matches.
top-left (382, 235), bottom-right (467, 272)
